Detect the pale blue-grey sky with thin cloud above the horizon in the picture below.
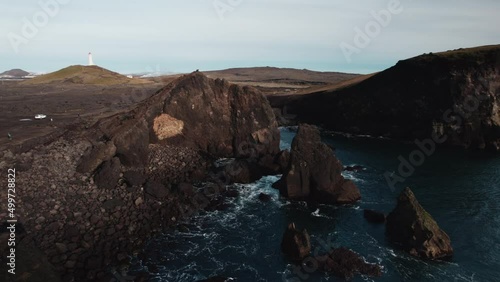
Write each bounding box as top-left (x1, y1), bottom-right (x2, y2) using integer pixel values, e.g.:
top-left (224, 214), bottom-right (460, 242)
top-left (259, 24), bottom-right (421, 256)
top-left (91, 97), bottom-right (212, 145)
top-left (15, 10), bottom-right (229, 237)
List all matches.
top-left (0, 0), bottom-right (500, 73)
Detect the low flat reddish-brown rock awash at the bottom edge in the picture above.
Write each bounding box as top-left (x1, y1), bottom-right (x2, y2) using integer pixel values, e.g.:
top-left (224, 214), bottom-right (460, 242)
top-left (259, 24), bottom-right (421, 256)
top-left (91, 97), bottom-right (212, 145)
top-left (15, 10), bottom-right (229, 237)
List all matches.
top-left (315, 247), bottom-right (382, 280)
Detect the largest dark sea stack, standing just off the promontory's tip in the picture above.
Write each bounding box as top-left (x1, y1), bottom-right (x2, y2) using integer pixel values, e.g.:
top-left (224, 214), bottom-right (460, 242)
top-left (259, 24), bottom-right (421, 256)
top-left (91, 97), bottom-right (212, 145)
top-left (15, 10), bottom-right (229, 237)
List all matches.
top-left (275, 124), bottom-right (361, 204)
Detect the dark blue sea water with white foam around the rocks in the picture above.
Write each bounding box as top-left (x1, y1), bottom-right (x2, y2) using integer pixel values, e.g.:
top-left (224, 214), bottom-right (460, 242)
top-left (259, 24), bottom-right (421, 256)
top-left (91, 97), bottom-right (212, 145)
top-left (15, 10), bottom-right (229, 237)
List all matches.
top-left (132, 128), bottom-right (500, 281)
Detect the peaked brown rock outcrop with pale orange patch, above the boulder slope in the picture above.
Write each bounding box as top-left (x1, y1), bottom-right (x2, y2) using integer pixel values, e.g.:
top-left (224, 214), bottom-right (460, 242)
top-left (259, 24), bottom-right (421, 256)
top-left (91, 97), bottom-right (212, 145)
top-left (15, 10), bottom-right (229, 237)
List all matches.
top-left (82, 72), bottom-right (280, 187)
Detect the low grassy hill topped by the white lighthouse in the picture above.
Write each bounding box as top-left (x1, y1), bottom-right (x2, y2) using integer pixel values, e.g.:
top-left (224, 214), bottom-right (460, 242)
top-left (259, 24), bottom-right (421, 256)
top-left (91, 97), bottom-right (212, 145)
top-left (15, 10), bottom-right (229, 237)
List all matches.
top-left (22, 65), bottom-right (149, 85)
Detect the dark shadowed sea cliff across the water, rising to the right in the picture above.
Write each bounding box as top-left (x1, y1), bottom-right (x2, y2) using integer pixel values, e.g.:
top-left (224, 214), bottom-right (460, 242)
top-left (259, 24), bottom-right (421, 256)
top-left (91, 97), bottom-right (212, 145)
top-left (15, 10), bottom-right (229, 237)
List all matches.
top-left (280, 45), bottom-right (500, 151)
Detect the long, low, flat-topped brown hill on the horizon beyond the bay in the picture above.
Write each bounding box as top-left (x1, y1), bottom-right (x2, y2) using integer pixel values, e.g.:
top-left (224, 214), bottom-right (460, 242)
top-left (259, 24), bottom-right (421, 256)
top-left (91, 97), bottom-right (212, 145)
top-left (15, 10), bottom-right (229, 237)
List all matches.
top-left (203, 67), bottom-right (359, 85)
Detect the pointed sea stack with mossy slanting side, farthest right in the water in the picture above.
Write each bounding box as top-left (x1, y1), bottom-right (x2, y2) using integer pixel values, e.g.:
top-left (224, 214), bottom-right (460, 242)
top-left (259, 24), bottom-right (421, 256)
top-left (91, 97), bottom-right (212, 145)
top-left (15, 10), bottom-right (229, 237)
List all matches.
top-left (386, 188), bottom-right (453, 259)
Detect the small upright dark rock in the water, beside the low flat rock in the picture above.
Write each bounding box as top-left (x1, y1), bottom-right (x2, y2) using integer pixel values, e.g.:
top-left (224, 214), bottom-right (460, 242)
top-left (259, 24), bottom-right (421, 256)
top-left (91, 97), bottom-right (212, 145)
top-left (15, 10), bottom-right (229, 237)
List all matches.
top-left (281, 223), bottom-right (311, 262)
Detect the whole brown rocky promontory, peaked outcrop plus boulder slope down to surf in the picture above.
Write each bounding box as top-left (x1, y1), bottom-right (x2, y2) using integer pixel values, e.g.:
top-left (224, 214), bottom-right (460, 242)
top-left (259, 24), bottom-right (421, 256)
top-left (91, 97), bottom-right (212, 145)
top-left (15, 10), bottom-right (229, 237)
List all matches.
top-left (0, 72), bottom-right (279, 281)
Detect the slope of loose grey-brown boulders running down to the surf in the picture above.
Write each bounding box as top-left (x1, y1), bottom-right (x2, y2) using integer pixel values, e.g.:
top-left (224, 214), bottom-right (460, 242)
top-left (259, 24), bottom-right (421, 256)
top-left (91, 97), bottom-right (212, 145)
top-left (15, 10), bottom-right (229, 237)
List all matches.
top-left (0, 134), bottom-right (229, 281)
